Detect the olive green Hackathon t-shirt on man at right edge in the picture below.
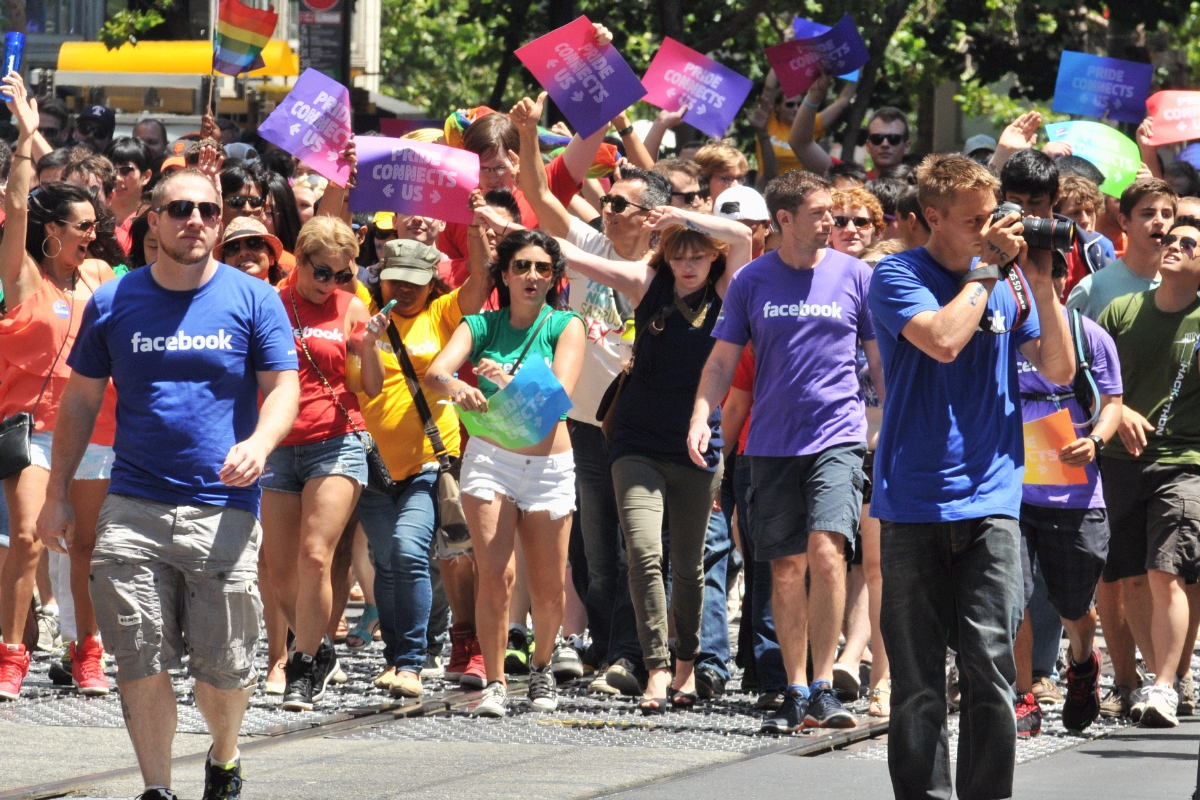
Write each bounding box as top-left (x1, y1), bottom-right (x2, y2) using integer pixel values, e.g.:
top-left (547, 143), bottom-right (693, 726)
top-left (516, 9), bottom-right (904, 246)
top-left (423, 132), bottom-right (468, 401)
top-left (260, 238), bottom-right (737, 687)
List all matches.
top-left (1097, 289), bottom-right (1200, 464)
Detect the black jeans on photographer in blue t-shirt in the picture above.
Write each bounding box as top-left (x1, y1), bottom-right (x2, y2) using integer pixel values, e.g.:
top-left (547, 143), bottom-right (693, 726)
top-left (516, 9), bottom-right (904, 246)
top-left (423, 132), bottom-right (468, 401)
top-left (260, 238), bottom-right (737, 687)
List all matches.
top-left (880, 517), bottom-right (1024, 800)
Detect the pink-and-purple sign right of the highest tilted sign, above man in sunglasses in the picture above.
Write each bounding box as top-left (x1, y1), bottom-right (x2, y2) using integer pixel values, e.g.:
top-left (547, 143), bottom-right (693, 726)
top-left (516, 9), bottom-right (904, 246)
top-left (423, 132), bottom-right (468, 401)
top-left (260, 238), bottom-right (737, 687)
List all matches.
top-left (642, 37), bottom-right (754, 139)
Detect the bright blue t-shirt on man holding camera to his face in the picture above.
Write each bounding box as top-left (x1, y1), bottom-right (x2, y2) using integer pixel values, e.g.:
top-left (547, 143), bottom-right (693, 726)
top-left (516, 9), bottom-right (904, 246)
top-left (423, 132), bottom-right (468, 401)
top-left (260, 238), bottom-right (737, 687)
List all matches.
top-left (870, 247), bottom-right (1042, 522)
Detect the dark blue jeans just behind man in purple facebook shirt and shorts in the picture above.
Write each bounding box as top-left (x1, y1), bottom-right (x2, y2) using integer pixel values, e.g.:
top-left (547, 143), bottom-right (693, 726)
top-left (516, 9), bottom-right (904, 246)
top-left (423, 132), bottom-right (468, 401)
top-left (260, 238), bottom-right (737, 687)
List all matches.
top-left (733, 458), bottom-right (787, 692)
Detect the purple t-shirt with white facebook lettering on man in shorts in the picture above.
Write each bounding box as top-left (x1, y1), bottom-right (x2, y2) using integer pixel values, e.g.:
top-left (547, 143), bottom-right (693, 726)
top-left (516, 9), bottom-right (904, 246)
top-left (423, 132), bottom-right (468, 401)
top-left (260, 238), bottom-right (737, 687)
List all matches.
top-left (713, 248), bottom-right (875, 457)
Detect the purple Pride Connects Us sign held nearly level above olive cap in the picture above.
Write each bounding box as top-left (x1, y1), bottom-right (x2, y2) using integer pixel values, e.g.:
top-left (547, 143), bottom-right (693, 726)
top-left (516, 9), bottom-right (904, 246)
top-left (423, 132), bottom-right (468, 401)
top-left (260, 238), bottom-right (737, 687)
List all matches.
top-left (350, 136), bottom-right (479, 224)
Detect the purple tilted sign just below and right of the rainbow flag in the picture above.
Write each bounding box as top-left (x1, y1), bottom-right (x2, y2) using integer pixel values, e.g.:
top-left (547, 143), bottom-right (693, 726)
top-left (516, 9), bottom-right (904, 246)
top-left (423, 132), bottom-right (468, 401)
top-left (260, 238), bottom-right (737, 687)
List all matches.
top-left (258, 67), bottom-right (350, 186)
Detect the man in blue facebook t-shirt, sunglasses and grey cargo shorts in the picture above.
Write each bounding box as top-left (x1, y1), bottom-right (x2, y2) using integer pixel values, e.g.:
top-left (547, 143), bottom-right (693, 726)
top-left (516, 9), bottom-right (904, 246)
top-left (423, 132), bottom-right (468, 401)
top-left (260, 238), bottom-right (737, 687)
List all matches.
top-left (38, 169), bottom-right (300, 800)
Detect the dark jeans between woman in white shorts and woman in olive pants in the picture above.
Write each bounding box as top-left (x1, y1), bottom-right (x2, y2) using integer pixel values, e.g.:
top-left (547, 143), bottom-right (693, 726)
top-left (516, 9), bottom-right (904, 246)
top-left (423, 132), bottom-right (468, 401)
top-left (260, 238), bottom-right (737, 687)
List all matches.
top-left (568, 420), bottom-right (642, 666)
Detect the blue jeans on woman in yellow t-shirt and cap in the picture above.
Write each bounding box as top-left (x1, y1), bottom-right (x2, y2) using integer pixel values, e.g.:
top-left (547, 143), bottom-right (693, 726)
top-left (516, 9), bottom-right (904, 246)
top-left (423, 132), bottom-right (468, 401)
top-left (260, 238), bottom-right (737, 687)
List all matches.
top-left (359, 473), bottom-right (438, 674)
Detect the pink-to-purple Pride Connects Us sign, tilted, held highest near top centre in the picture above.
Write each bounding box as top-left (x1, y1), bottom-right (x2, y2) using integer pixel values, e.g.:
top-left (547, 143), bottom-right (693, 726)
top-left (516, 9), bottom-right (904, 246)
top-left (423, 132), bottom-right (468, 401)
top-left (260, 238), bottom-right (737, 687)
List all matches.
top-left (516, 17), bottom-right (646, 137)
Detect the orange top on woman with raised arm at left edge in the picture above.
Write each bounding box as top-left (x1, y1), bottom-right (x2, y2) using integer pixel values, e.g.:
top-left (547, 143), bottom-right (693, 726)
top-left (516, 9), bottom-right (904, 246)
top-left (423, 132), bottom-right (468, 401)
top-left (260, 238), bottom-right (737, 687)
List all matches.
top-left (0, 259), bottom-right (116, 446)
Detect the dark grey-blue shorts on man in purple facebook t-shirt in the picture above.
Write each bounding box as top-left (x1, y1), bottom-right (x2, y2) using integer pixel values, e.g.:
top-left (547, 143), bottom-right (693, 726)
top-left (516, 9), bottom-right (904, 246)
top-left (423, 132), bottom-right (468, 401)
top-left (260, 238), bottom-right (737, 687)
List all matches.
top-left (745, 444), bottom-right (866, 561)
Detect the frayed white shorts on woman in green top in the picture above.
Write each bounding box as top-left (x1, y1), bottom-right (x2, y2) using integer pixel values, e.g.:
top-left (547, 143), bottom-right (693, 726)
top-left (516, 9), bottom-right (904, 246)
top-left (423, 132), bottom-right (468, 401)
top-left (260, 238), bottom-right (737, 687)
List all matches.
top-left (461, 437), bottom-right (575, 519)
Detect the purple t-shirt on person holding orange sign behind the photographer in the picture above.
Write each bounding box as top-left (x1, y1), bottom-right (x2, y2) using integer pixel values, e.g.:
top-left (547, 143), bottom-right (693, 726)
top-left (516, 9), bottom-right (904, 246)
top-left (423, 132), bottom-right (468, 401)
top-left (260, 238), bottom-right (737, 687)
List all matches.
top-left (1016, 311), bottom-right (1123, 509)
